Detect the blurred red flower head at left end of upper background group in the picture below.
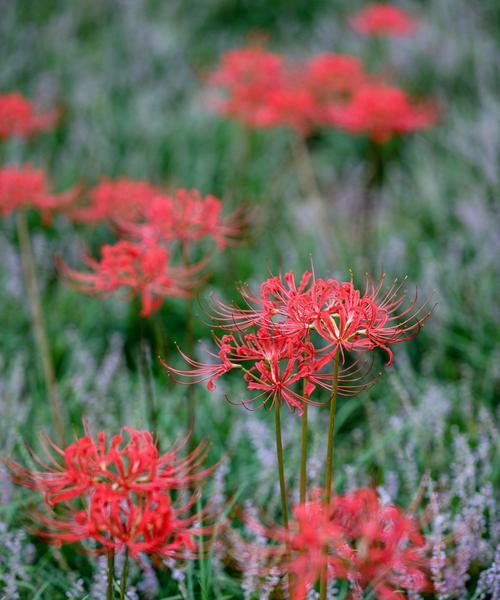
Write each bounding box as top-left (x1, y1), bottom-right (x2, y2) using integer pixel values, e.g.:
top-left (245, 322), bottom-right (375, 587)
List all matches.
top-left (209, 47), bottom-right (284, 127)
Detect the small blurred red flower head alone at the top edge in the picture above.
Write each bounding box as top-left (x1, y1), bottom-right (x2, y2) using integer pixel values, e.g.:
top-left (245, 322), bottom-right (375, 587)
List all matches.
top-left (349, 2), bottom-right (418, 37)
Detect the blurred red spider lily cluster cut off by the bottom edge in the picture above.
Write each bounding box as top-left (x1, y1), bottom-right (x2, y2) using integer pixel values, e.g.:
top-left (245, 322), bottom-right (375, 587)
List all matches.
top-left (250, 488), bottom-right (430, 600)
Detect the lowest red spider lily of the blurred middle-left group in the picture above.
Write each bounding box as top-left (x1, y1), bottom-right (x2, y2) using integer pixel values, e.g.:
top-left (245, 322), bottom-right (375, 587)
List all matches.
top-left (61, 240), bottom-right (200, 317)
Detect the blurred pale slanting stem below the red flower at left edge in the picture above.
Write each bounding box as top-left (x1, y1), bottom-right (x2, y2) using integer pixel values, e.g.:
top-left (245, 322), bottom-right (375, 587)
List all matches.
top-left (16, 211), bottom-right (65, 443)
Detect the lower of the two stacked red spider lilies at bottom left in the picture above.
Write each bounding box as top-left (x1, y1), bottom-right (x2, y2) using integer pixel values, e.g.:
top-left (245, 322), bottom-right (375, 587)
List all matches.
top-left (36, 484), bottom-right (210, 559)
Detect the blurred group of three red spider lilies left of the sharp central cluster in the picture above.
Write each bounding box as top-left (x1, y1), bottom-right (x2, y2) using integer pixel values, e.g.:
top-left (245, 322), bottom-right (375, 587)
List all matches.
top-left (61, 178), bottom-right (244, 317)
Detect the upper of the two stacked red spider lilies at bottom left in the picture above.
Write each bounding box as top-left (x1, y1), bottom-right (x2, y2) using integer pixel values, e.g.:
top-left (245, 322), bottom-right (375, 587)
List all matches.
top-left (6, 427), bottom-right (213, 506)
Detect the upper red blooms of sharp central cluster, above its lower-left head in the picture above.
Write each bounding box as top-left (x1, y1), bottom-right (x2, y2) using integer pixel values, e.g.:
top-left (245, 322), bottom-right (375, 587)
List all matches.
top-left (205, 271), bottom-right (431, 368)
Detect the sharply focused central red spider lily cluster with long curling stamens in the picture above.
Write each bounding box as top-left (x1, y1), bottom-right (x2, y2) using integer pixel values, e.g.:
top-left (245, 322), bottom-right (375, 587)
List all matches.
top-left (165, 271), bottom-right (430, 414)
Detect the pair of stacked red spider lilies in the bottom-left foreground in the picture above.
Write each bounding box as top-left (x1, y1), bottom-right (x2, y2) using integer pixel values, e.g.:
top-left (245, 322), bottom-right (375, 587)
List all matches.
top-left (8, 427), bottom-right (213, 559)
